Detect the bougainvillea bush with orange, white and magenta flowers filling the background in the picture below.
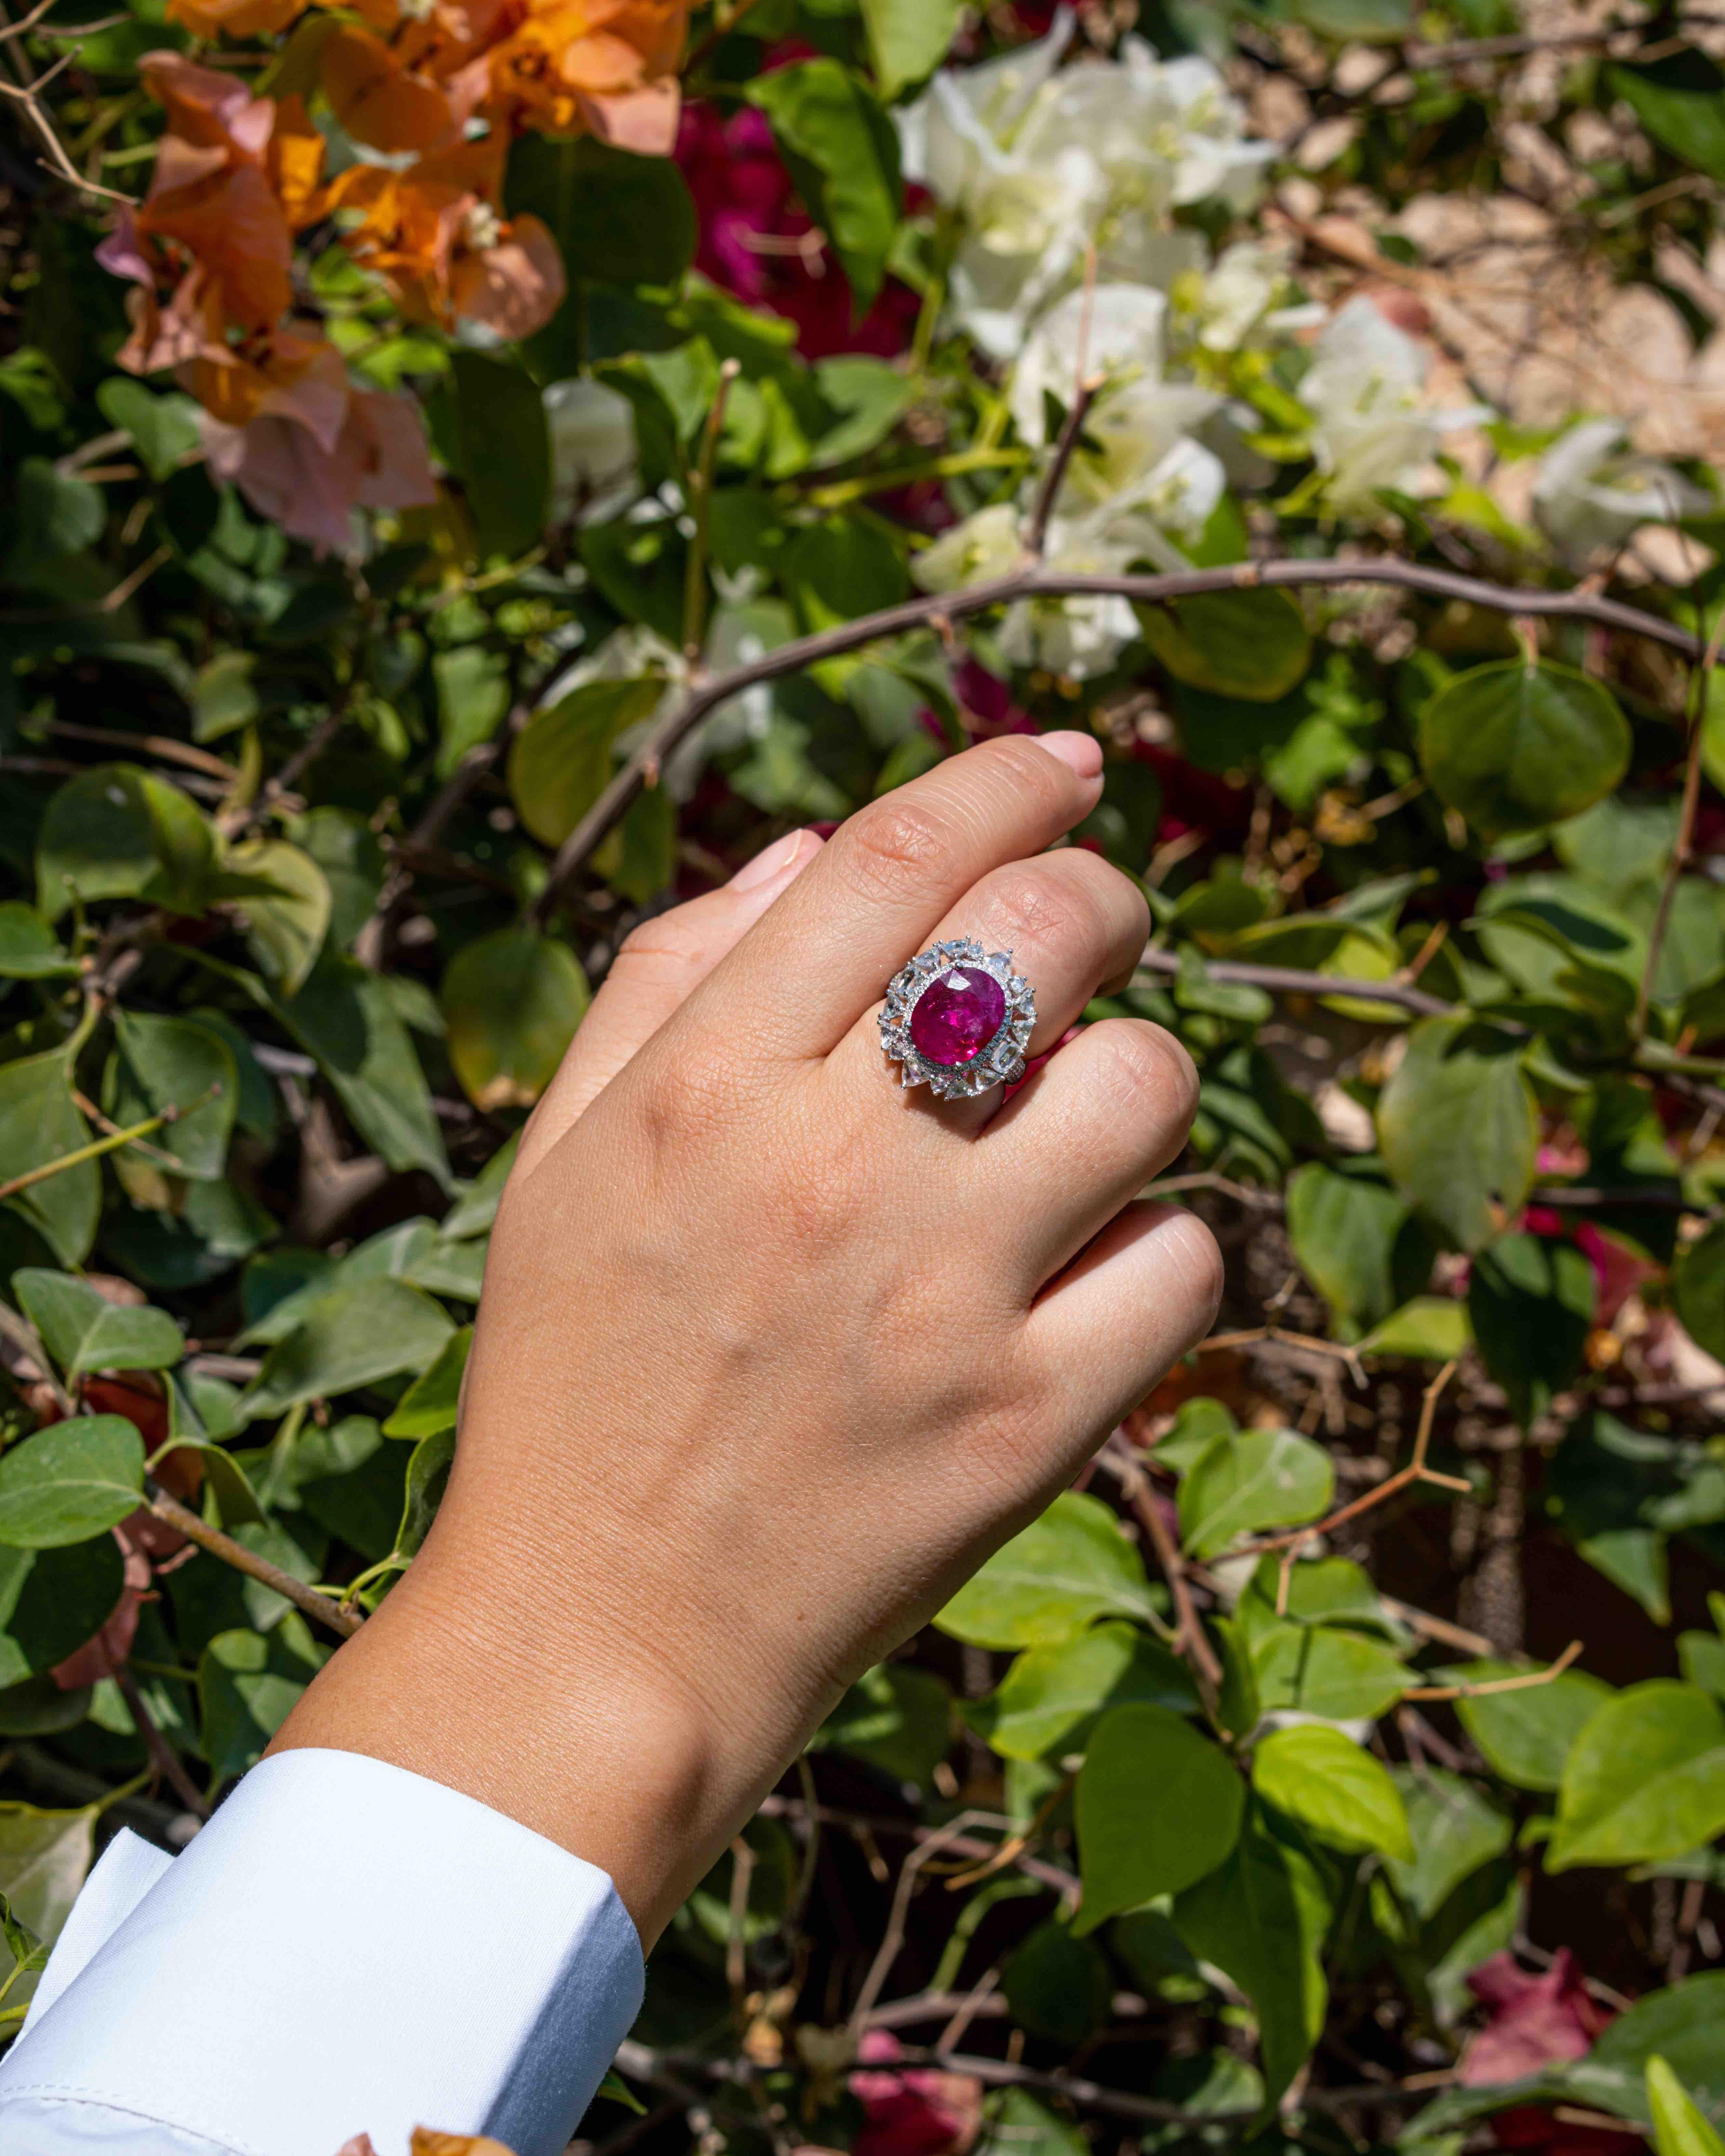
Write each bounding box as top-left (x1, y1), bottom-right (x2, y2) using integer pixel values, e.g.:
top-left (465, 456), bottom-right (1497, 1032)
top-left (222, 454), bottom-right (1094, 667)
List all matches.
top-left (0, 0), bottom-right (1725, 2156)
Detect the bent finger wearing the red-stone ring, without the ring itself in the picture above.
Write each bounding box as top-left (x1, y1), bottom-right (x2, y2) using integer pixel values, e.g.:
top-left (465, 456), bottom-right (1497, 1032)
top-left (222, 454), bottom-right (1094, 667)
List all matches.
top-left (835, 847), bottom-right (1149, 1130)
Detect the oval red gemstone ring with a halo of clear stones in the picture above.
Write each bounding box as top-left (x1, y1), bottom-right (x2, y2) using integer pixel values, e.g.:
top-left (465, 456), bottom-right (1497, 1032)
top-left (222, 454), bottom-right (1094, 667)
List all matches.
top-left (880, 936), bottom-right (1037, 1099)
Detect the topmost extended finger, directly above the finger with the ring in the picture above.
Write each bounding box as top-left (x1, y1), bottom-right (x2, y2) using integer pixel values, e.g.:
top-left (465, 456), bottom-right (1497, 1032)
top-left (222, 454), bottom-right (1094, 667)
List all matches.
top-left (701, 733), bottom-right (1102, 1057)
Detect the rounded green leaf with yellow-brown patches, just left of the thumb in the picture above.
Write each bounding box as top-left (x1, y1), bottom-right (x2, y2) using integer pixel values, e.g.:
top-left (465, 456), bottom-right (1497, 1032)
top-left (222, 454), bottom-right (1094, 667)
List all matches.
top-left (442, 929), bottom-right (591, 1110)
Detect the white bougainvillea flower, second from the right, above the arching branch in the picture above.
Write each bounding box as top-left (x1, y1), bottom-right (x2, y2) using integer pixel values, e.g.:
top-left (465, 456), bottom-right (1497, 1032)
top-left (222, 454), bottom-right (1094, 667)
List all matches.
top-left (1300, 298), bottom-right (1490, 509)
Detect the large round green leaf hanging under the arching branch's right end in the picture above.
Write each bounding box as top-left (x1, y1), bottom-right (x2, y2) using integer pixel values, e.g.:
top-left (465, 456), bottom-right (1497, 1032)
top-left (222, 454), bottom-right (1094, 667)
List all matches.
top-left (1419, 660), bottom-right (1630, 839)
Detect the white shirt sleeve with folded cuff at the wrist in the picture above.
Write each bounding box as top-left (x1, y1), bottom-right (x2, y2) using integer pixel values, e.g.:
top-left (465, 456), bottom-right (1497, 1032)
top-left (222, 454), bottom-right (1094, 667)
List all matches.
top-left (0, 1751), bottom-right (643, 2156)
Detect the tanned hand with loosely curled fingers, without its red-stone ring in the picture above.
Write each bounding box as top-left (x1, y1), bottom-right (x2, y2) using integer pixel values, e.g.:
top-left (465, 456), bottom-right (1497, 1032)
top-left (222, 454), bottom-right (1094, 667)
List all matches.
top-left (276, 733), bottom-right (1221, 1945)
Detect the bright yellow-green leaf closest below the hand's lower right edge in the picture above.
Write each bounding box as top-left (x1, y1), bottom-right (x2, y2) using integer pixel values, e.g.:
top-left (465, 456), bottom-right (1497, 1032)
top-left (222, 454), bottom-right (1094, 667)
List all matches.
top-left (934, 1490), bottom-right (1156, 1647)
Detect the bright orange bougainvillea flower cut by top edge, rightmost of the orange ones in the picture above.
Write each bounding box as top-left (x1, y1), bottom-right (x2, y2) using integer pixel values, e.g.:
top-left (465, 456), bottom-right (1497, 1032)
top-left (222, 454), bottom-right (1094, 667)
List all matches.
top-left (474, 0), bottom-right (688, 157)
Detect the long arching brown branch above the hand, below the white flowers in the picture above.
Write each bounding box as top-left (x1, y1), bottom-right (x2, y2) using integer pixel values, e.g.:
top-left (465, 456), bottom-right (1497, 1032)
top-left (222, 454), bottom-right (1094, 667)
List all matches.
top-left (533, 556), bottom-right (1704, 918)
